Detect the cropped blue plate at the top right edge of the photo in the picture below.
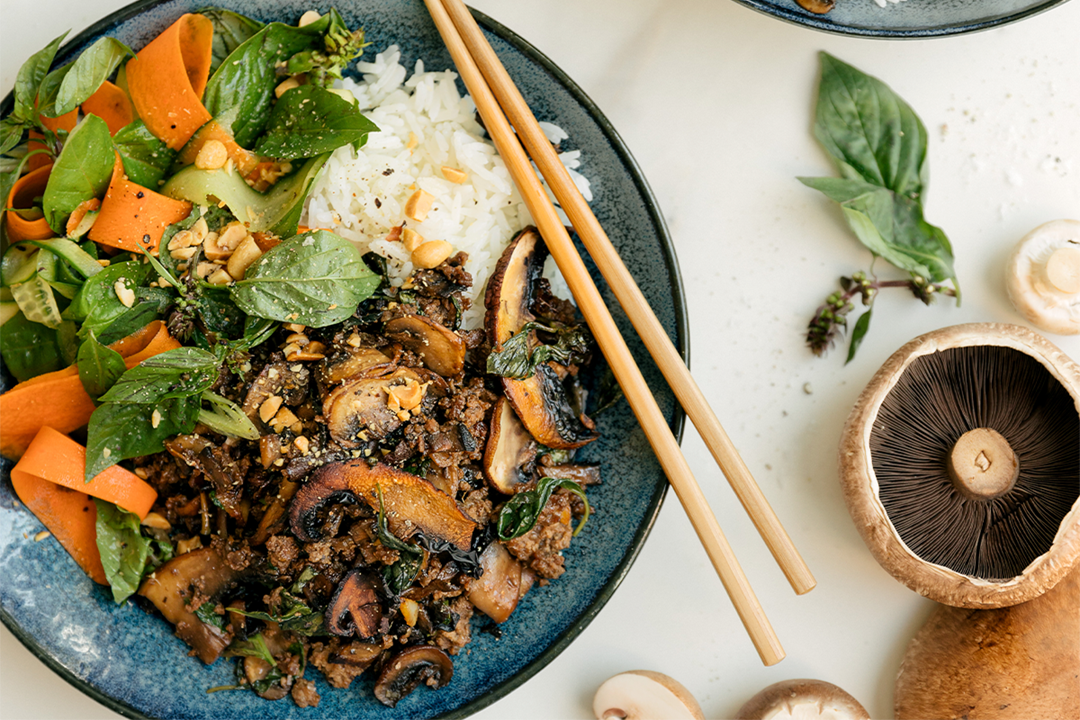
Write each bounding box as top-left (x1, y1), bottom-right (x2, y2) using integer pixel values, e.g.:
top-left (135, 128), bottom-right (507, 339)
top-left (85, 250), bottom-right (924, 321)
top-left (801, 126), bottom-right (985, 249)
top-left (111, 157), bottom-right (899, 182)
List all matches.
top-left (737, 0), bottom-right (1066, 39)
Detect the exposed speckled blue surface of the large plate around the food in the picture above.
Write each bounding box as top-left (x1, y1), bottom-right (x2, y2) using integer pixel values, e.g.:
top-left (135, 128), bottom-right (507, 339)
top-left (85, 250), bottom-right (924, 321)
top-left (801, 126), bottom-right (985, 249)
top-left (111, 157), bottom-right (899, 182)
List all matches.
top-left (0, 0), bottom-right (687, 720)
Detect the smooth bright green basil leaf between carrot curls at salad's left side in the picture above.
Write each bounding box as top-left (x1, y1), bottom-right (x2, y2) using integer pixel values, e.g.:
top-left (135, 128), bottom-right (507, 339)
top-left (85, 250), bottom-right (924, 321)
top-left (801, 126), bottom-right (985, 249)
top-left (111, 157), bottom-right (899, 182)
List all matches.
top-left (42, 116), bottom-right (114, 235)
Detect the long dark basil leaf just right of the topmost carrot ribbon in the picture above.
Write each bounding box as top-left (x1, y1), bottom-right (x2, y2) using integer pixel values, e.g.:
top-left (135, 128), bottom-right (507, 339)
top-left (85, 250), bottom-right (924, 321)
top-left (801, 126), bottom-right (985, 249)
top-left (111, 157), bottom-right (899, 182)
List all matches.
top-left (203, 15), bottom-right (330, 148)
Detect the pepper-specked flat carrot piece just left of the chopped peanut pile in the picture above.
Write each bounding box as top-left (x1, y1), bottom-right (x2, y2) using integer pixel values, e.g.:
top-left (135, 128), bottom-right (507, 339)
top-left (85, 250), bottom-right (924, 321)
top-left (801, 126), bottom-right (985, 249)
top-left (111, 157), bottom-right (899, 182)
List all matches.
top-left (87, 155), bottom-right (191, 253)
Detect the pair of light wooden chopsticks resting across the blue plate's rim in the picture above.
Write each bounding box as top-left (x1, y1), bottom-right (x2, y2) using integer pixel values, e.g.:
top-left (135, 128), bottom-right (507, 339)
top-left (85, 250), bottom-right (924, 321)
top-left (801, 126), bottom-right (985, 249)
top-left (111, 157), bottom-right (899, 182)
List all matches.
top-left (424, 0), bottom-right (815, 665)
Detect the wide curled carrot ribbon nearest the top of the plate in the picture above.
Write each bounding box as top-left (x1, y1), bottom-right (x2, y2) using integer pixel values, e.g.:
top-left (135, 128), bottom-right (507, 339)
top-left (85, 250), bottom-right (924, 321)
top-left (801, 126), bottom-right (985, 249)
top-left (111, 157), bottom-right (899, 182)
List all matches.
top-left (126, 13), bottom-right (214, 150)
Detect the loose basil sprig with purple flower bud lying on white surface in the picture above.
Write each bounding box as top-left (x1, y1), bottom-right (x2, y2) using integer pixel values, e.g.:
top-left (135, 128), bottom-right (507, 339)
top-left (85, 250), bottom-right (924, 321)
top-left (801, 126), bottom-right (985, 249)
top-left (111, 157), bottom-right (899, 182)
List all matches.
top-left (799, 53), bottom-right (960, 362)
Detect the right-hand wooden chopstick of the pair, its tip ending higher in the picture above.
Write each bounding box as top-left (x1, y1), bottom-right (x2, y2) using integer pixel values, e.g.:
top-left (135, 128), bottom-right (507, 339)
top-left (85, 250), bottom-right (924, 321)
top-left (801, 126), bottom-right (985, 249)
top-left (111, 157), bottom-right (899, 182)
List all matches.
top-left (434, 0), bottom-right (816, 595)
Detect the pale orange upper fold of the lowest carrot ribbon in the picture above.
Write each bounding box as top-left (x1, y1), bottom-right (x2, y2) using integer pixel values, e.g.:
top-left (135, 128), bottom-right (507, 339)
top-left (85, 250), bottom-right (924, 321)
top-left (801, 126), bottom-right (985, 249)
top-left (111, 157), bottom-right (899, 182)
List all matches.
top-left (11, 426), bottom-right (158, 520)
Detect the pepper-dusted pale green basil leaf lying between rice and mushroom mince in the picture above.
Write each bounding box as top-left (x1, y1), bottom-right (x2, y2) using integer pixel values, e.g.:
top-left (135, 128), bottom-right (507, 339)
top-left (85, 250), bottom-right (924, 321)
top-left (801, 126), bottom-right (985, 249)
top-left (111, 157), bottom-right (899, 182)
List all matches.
top-left (231, 230), bottom-right (380, 327)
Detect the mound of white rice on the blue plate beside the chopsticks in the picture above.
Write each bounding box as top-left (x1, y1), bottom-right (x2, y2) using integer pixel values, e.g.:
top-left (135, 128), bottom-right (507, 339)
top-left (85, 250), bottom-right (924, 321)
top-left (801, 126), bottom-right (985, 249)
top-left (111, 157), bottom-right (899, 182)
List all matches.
top-left (300, 45), bottom-right (592, 329)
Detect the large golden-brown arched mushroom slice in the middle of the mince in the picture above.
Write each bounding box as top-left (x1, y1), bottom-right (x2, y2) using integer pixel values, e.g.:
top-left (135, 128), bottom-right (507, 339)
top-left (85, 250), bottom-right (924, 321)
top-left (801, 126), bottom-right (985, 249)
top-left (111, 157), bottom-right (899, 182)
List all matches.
top-left (289, 459), bottom-right (476, 551)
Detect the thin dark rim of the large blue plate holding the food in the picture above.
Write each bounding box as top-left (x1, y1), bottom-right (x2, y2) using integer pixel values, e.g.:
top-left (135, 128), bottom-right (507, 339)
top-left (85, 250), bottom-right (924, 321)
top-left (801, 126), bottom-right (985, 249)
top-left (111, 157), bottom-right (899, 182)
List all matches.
top-left (0, 0), bottom-right (690, 720)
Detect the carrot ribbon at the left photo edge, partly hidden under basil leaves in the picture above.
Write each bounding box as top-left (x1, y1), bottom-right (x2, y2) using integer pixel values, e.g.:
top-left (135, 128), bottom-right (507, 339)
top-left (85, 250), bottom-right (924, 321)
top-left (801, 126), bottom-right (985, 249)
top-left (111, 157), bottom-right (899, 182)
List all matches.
top-left (0, 321), bottom-right (180, 460)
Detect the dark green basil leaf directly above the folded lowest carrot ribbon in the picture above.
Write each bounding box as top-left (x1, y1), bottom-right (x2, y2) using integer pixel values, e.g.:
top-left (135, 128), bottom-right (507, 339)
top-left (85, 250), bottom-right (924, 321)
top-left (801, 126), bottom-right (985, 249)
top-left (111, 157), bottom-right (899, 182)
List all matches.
top-left (85, 395), bottom-right (200, 481)
